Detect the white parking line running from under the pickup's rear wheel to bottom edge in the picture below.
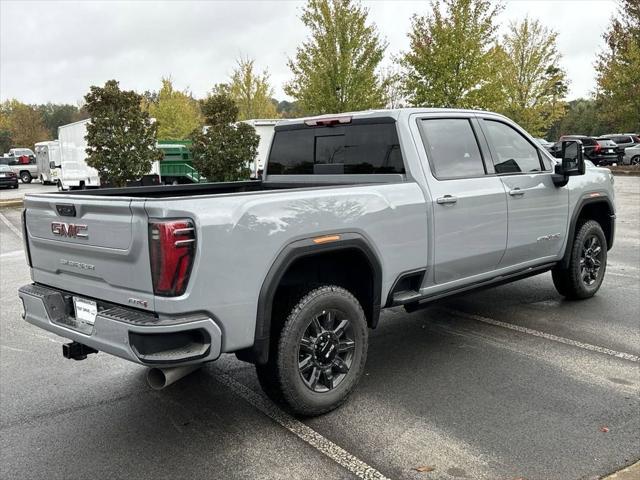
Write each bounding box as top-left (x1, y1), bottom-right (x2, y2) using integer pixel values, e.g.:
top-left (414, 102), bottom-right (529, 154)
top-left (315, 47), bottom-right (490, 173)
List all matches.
top-left (215, 368), bottom-right (387, 480)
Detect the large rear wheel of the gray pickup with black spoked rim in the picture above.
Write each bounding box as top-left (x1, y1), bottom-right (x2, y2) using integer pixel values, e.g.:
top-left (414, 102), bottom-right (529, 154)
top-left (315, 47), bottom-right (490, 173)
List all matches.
top-left (256, 285), bottom-right (368, 416)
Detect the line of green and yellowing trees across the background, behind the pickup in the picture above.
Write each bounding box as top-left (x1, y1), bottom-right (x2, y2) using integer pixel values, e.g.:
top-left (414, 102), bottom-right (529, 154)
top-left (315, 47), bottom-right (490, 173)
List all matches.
top-left (0, 0), bottom-right (640, 157)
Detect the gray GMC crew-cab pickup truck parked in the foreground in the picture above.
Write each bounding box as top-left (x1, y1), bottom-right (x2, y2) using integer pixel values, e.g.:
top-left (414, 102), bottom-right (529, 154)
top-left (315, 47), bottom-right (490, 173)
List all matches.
top-left (19, 109), bottom-right (615, 415)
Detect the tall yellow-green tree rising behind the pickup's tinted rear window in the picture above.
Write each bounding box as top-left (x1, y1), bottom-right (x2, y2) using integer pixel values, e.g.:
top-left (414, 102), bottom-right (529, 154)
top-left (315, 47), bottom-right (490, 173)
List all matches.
top-left (284, 0), bottom-right (387, 114)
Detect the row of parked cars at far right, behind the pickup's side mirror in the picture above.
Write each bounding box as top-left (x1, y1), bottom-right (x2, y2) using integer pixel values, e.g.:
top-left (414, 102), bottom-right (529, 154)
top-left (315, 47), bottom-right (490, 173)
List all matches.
top-left (537, 133), bottom-right (640, 165)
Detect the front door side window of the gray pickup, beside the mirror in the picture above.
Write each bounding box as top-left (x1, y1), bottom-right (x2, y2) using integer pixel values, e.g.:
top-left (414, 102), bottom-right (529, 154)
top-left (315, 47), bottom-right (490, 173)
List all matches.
top-left (484, 120), bottom-right (542, 173)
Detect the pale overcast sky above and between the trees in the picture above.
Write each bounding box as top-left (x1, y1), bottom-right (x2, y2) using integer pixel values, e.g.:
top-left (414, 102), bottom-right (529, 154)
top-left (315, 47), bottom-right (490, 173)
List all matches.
top-left (0, 0), bottom-right (616, 104)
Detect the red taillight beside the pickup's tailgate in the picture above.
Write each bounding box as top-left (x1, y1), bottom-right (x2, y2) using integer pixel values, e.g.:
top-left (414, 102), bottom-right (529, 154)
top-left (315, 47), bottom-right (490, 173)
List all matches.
top-left (149, 220), bottom-right (196, 297)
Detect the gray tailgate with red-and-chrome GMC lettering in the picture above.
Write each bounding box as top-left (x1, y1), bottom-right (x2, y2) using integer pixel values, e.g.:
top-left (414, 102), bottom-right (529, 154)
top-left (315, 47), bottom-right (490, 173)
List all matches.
top-left (24, 195), bottom-right (154, 310)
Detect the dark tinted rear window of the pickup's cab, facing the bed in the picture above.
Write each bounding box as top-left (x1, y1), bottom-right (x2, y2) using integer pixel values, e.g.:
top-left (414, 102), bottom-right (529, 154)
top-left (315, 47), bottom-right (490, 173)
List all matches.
top-left (268, 123), bottom-right (404, 175)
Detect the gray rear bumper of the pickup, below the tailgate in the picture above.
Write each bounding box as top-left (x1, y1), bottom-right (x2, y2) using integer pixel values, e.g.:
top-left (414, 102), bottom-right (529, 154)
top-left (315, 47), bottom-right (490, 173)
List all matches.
top-left (18, 284), bottom-right (222, 367)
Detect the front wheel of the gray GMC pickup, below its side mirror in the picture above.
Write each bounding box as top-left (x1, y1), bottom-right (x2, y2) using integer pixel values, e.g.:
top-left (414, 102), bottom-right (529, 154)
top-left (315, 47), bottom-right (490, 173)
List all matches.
top-left (551, 220), bottom-right (607, 300)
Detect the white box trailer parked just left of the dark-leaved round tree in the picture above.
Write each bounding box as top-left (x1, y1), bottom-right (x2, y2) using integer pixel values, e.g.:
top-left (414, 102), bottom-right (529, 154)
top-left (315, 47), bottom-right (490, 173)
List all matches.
top-left (58, 119), bottom-right (100, 190)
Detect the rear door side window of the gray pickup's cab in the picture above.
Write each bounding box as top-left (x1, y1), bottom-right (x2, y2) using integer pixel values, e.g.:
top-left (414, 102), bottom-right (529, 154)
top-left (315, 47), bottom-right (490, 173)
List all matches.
top-left (422, 118), bottom-right (486, 179)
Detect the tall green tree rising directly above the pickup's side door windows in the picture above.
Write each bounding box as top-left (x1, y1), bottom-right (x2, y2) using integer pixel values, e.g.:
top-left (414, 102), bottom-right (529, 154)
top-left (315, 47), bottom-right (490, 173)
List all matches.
top-left (399, 0), bottom-right (502, 109)
